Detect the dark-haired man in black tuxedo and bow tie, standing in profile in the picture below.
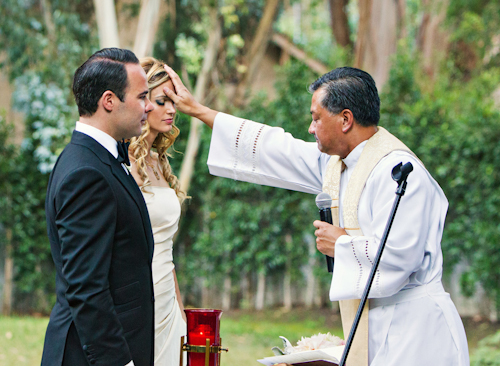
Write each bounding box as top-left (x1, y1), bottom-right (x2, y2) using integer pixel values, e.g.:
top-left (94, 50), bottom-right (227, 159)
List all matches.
top-left (42, 48), bottom-right (154, 366)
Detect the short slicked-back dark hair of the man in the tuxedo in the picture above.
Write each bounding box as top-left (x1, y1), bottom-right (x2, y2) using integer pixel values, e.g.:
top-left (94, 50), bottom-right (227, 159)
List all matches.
top-left (73, 48), bottom-right (139, 117)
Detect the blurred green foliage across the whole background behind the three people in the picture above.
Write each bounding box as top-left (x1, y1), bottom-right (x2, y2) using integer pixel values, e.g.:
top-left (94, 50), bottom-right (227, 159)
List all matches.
top-left (0, 0), bottom-right (500, 328)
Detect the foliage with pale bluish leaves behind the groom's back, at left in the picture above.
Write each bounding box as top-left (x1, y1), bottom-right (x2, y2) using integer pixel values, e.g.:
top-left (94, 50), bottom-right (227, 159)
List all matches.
top-left (0, 0), bottom-right (98, 312)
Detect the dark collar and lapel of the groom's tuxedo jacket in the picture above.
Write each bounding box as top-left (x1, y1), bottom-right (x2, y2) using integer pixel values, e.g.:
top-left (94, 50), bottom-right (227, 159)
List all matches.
top-left (71, 131), bottom-right (154, 263)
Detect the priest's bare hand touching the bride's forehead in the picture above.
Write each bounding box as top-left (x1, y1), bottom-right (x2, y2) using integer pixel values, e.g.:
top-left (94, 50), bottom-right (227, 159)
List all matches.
top-left (163, 65), bottom-right (218, 128)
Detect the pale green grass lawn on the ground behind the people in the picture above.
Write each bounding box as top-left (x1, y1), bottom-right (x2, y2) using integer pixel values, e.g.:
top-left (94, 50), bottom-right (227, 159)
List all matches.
top-left (0, 309), bottom-right (500, 366)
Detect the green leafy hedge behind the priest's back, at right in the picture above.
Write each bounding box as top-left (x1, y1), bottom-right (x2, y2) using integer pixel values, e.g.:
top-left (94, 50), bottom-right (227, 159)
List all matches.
top-left (381, 46), bottom-right (500, 312)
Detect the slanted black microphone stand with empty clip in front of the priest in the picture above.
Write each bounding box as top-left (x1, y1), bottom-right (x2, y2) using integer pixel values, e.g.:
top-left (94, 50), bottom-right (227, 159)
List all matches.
top-left (339, 163), bottom-right (413, 366)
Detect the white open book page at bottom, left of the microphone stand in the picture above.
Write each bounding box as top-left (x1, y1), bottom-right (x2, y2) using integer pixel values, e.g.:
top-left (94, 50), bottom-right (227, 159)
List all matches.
top-left (257, 346), bottom-right (344, 366)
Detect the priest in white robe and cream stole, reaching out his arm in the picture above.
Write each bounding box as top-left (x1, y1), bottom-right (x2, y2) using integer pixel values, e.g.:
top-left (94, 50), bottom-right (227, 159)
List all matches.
top-left (165, 66), bottom-right (469, 366)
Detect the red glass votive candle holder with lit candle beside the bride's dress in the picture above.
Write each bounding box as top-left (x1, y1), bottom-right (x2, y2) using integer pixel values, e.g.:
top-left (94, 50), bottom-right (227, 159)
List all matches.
top-left (184, 309), bottom-right (222, 366)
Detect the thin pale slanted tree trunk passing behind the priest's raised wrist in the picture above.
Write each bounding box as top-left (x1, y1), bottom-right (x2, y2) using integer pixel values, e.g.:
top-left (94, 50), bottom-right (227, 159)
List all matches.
top-left (179, 8), bottom-right (222, 192)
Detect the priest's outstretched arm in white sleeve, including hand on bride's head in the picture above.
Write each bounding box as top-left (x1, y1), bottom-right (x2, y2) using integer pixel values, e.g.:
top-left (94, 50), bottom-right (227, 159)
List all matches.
top-left (164, 65), bottom-right (330, 194)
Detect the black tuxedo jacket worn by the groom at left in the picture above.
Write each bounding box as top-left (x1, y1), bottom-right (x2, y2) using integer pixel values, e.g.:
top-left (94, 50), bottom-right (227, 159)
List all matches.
top-left (42, 131), bottom-right (154, 366)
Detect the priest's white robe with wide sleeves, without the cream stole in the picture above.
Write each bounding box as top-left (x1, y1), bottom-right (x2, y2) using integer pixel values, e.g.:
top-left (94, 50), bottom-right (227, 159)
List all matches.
top-left (208, 113), bottom-right (469, 366)
